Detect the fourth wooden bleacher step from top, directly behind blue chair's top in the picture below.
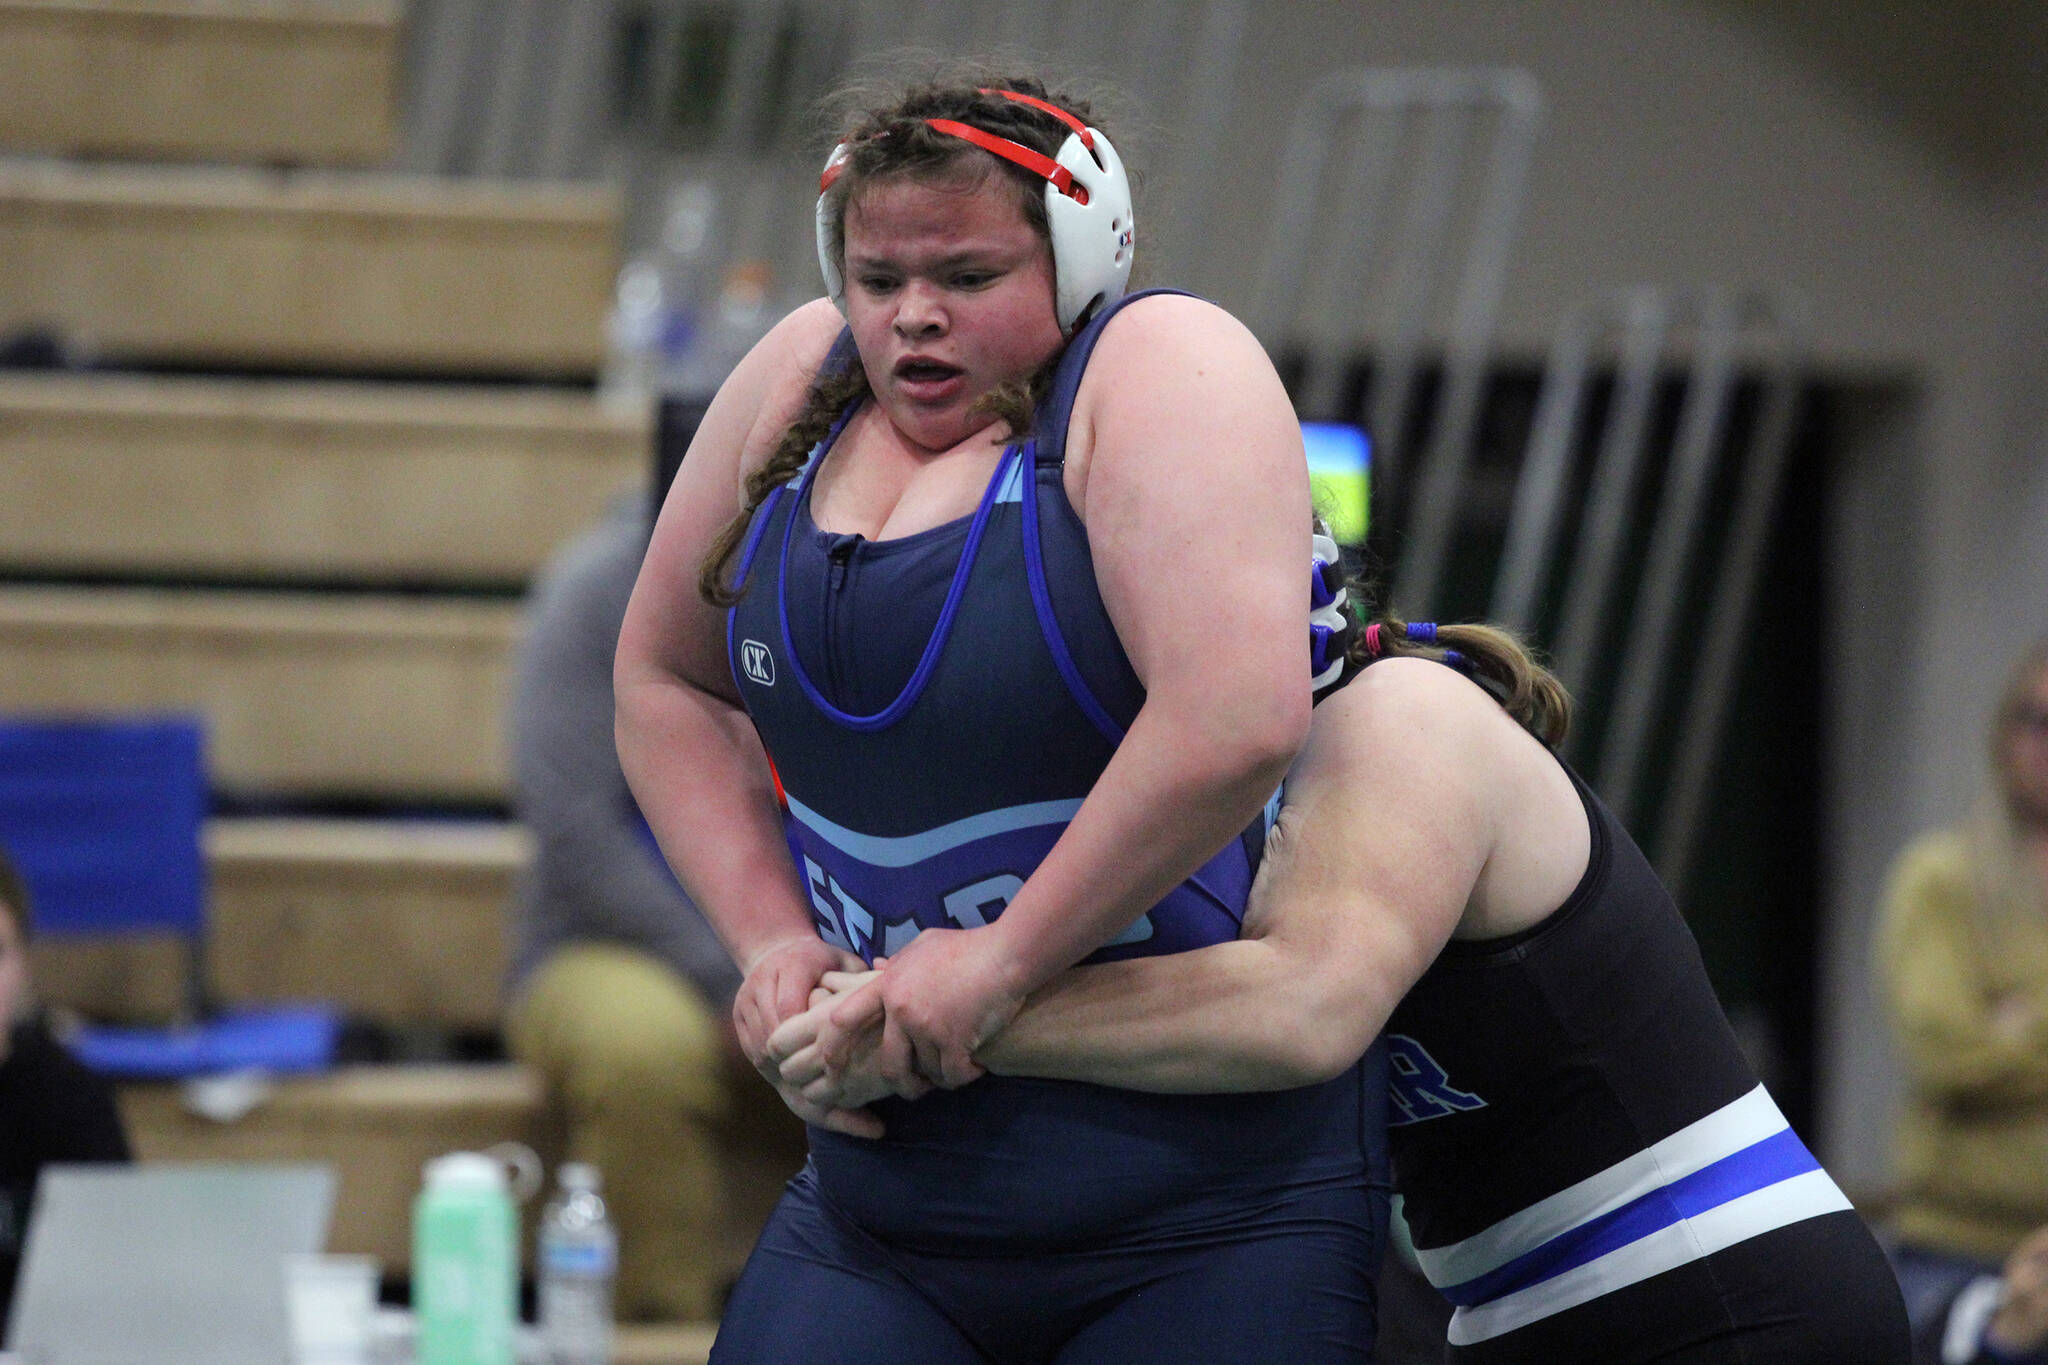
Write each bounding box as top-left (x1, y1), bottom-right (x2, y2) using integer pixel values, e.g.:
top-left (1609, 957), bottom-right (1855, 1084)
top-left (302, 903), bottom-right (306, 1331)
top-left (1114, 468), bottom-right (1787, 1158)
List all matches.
top-left (0, 585), bottom-right (520, 800)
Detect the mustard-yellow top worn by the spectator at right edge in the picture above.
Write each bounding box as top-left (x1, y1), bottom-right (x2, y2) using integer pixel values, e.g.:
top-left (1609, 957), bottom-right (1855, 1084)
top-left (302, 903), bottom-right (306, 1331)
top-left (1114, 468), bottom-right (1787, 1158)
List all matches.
top-left (1878, 831), bottom-right (2048, 1261)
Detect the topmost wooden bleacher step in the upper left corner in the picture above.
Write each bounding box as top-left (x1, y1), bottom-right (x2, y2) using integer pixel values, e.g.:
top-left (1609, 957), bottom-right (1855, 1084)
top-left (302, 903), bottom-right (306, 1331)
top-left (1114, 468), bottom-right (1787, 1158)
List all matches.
top-left (0, 0), bottom-right (401, 166)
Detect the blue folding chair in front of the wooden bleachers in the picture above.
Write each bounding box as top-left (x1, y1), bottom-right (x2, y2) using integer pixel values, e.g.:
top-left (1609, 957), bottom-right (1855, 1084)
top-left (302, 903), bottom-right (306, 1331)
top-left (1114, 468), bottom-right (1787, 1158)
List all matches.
top-left (0, 716), bottom-right (340, 1078)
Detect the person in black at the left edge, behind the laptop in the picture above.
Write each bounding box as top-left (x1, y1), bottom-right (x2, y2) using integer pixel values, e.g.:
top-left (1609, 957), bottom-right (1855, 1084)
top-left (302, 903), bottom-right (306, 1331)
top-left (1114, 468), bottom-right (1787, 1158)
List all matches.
top-left (0, 851), bottom-right (129, 1336)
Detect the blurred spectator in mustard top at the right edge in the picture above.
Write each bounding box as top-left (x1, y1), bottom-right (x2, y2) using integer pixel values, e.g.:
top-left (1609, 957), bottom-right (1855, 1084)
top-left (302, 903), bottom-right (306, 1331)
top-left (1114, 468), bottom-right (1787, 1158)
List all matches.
top-left (1878, 639), bottom-right (2048, 1359)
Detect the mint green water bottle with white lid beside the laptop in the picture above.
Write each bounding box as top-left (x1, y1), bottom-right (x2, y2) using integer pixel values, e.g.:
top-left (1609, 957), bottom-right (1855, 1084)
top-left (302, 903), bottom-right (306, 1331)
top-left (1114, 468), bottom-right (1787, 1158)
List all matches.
top-left (412, 1152), bottom-right (518, 1365)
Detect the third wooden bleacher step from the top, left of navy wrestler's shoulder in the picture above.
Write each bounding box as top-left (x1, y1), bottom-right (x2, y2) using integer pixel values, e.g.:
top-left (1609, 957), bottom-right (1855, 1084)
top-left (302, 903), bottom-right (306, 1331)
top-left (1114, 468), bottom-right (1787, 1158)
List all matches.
top-left (0, 375), bottom-right (651, 583)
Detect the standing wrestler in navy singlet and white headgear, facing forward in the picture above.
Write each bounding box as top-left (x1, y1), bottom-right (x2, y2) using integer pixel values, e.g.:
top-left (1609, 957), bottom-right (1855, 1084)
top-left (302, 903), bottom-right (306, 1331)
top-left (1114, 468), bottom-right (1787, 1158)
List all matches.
top-left (616, 82), bottom-right (1384, 1365)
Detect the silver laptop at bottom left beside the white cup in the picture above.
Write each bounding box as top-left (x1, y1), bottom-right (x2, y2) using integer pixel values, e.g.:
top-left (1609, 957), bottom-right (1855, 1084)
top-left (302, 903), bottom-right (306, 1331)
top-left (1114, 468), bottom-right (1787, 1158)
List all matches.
top-left (6, 1162), bottom-right (336, 1365)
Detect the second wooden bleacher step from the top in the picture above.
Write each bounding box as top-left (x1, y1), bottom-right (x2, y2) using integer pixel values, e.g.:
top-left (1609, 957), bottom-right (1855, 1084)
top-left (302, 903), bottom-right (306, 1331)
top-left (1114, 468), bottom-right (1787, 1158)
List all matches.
top-left (0, 162), bottom-right (621, 377)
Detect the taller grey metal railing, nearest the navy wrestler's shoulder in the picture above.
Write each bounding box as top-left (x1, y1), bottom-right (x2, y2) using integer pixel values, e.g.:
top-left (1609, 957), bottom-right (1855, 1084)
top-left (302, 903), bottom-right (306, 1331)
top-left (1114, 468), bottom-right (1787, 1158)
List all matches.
top-left (1253, 70), bottom-right (1542, 616)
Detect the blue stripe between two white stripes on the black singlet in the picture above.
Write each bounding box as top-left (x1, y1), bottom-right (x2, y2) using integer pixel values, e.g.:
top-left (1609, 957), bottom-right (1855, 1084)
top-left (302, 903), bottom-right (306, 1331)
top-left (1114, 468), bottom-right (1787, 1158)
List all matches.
top-left (1440, 1128), bottom-right (1821, 1308)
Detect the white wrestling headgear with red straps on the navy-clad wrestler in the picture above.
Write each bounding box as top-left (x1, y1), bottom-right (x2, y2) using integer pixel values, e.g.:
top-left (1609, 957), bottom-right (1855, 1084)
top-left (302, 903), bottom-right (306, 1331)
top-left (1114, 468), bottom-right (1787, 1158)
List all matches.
top-left (817, 90), bottom-right (1135, 336)
